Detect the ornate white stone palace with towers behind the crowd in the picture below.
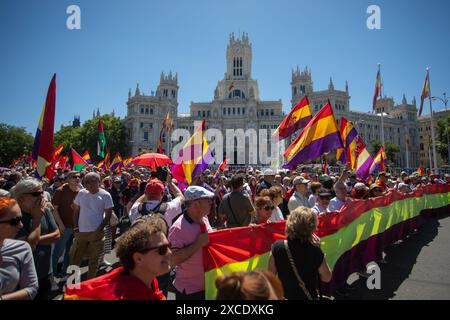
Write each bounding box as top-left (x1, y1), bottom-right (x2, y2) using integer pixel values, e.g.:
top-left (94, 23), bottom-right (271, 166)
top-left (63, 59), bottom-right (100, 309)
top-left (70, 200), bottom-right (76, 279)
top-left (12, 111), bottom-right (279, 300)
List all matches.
top-left (125, 33), bottom-right (442, 168)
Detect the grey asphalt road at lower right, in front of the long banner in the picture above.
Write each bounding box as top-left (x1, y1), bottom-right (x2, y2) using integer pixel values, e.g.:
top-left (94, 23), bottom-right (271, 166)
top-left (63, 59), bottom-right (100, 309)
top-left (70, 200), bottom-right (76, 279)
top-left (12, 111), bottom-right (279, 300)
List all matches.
top-left (336, 212), bottom-right (450, 300)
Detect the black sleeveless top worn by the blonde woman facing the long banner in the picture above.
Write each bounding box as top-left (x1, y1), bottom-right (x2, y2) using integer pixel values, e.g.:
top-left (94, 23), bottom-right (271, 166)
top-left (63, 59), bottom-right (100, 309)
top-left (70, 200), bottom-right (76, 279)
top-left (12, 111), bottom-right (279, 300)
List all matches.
top-left (272, 240), bottom-right (324, 300)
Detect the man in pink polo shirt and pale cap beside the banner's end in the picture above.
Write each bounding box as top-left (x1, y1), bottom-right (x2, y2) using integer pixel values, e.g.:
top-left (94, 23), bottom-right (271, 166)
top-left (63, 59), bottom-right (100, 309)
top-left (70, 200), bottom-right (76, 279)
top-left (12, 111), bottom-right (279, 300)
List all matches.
top-left (169, 186), bottom-right (214, 300)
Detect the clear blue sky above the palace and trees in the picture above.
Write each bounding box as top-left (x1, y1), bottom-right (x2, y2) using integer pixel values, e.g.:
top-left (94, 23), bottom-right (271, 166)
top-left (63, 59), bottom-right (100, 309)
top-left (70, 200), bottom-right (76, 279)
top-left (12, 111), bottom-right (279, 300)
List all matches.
top-left (0, 0), bottom-right (450, 133)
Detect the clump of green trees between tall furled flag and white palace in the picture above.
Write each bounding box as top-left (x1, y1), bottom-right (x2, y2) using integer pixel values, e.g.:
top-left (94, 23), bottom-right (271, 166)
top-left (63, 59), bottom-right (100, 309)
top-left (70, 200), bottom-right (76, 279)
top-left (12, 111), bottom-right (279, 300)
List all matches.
top-left (54, 115), bottom-right (128, 163)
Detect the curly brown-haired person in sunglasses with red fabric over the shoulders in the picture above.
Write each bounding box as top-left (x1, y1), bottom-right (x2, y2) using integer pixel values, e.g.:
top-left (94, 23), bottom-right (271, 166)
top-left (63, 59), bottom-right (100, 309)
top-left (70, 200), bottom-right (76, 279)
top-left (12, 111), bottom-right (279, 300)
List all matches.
top-left (64, 217), bottom-right (172, 300)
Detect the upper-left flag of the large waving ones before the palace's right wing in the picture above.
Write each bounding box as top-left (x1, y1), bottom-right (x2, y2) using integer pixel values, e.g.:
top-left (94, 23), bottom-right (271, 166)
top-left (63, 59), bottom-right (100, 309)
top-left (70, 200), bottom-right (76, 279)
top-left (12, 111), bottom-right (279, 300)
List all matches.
top-left (272, 96), bottom-right (312, 140)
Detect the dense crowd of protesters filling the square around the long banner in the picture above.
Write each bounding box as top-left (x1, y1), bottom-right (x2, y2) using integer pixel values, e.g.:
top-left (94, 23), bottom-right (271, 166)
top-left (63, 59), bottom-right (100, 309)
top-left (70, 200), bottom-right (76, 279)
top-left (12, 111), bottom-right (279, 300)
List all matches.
top-left (0, 167), bottom-right (450, 300)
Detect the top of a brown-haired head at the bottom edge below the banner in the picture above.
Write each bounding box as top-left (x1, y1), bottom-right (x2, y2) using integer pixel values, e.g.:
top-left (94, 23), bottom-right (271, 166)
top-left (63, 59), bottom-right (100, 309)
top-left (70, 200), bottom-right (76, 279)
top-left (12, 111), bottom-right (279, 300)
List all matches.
top-left (216, 270), bottom-right (284, 300)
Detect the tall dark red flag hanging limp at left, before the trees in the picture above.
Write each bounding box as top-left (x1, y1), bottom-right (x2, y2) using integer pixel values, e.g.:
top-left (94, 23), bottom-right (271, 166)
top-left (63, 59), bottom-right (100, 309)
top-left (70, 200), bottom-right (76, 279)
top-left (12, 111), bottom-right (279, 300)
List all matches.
top-left (32, 74), bottom-right (56, 177)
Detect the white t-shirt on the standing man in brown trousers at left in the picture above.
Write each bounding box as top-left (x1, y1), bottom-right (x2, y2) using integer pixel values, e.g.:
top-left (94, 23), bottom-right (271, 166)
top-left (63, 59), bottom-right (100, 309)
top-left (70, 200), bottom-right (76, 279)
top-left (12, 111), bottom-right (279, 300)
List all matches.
top-left (74, 189), bottom-right (114, 232)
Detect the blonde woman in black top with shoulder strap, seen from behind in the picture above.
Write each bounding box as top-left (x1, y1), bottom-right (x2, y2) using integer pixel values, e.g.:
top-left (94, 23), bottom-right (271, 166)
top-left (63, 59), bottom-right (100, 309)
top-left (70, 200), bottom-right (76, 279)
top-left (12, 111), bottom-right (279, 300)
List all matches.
top-left (269, 207), bottom-right (331, 300)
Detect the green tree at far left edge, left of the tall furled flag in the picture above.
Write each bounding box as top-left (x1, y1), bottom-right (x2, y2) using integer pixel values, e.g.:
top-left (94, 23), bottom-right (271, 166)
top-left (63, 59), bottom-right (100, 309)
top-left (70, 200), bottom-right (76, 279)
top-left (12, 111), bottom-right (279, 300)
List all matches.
top-left (0, 123), bottom-right (34, 167)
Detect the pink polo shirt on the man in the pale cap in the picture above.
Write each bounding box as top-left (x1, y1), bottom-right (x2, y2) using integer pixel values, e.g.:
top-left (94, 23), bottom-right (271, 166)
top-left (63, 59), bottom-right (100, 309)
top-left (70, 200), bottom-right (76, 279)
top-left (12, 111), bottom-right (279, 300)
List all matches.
top-left (169, 213), bottom-right (213, 294)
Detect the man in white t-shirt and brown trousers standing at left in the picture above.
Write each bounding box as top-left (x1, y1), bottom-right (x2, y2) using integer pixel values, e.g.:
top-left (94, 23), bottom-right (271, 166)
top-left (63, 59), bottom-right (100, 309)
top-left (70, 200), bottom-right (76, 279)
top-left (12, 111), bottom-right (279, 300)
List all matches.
top-left (70, 172), bottom-right (114, 279)
